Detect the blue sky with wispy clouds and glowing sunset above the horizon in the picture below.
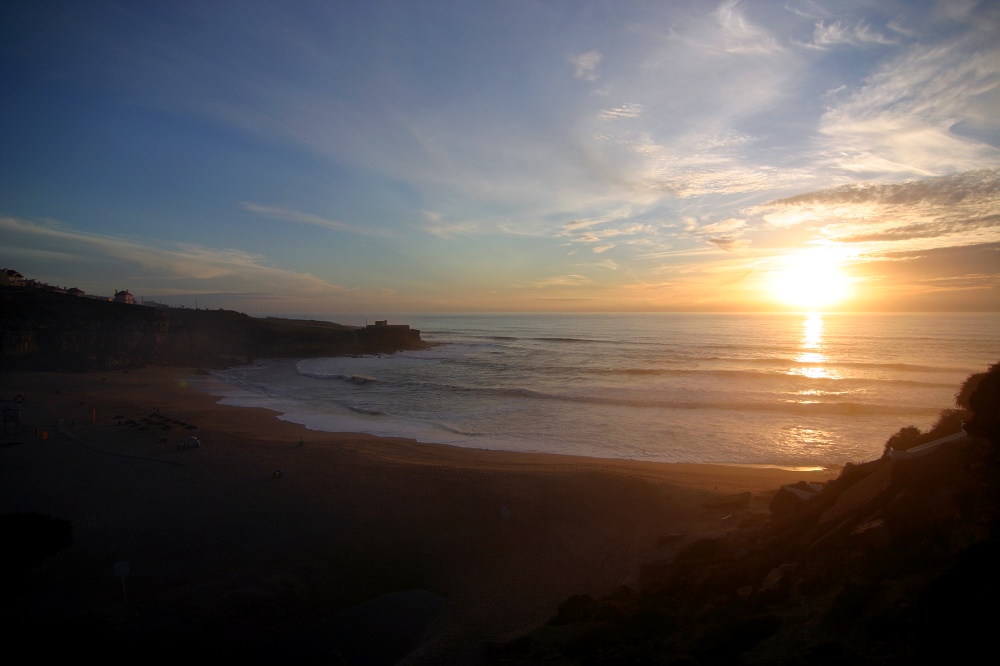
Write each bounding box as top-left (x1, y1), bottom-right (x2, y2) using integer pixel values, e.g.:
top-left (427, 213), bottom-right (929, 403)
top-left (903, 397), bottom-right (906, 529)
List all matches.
top-left (0, 0), bottom-right (1000, 317)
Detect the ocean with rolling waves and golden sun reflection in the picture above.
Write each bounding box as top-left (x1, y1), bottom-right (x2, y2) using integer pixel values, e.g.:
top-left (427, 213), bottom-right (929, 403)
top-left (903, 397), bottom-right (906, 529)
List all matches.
top-left (203, 313), bottom-right (1000, 468)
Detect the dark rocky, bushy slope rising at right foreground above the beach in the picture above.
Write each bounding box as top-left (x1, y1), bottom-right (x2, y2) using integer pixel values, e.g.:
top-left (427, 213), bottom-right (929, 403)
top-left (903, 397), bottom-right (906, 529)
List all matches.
top-left (493, 364), bottom-right (1000, 666)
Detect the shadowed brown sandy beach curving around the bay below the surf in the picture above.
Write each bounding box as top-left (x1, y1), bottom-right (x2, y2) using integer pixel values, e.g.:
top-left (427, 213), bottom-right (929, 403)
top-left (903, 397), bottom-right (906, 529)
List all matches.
top-left (0, 368), bottom-right (839, 664)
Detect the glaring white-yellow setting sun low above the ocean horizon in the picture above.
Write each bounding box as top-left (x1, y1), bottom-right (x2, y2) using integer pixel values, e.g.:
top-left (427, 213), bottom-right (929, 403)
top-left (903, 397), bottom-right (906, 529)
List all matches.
top-left (771, 252), bottom-right (850, 310)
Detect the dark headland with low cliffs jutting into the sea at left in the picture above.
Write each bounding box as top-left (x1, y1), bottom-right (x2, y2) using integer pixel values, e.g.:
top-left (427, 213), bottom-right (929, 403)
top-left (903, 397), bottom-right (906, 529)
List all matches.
top-left (0, 288), bottom-right (423, 370)
